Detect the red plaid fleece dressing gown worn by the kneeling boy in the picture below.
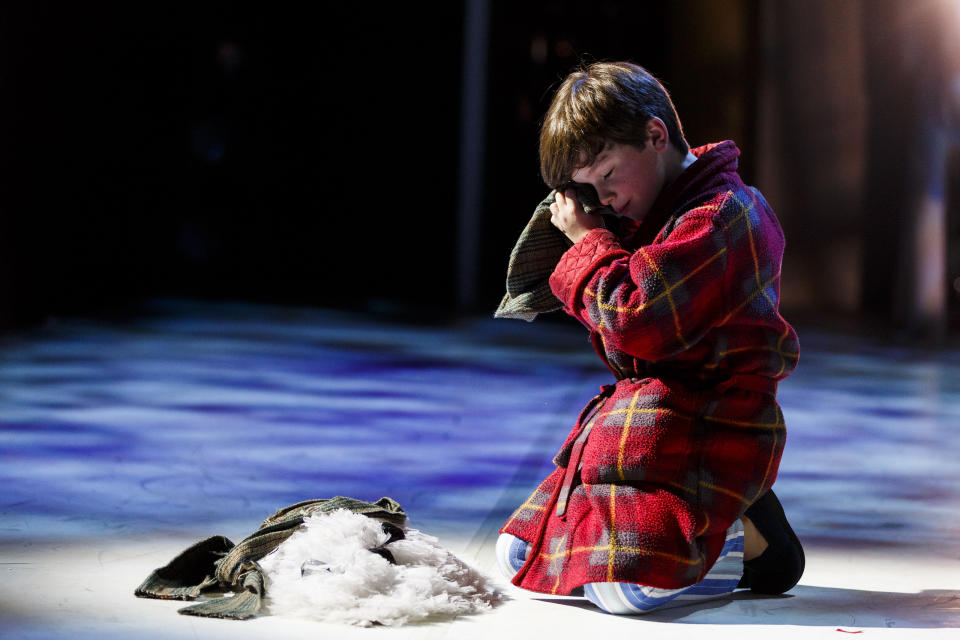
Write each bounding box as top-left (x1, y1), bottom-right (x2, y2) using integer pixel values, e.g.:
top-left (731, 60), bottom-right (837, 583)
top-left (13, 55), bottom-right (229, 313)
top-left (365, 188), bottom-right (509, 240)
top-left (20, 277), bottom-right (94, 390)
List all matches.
top-left (501, 141), bottom-right (799, 594)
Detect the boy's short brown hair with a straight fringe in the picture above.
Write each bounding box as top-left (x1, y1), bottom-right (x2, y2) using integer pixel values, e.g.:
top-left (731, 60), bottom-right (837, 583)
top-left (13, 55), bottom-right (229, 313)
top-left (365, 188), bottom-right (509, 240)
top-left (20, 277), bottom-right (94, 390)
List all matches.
top-left (540, 62), bottom-right (690, 189)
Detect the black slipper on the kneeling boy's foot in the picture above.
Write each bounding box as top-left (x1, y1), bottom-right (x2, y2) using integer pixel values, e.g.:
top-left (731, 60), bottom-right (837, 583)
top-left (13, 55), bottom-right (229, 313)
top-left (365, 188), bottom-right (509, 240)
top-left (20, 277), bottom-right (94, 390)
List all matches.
top-left (737, 491), bottom-right (806, 595)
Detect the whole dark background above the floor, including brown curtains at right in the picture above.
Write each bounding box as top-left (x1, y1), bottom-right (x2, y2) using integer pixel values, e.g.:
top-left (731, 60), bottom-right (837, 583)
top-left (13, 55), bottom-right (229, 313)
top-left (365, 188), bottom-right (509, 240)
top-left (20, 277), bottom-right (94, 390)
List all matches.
top-left (0, 0), bottom-right (960, 341)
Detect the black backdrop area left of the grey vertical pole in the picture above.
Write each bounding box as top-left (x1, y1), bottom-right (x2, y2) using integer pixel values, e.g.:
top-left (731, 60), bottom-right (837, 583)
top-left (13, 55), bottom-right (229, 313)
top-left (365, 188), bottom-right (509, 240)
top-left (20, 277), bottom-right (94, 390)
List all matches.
top-left (0, 3), bottom-right (462, 324)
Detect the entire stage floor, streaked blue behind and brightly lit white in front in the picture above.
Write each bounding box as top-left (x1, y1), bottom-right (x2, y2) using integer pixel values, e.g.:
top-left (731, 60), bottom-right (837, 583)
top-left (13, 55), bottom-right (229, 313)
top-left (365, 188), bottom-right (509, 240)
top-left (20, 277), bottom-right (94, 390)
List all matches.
top-left (0, 301), bottom-right (960, 639)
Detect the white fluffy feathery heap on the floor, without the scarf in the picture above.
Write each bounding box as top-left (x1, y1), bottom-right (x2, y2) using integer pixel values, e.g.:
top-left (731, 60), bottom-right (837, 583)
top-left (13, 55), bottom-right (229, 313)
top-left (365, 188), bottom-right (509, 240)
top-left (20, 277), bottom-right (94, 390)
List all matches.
top-left (260, 509), bottom-right (502, 626)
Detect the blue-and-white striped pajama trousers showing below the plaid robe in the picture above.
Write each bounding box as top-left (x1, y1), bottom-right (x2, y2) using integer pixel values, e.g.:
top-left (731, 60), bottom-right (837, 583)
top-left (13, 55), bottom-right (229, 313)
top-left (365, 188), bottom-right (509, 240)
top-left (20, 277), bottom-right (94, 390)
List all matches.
top-left (496, 520), bottom-right (743, 615)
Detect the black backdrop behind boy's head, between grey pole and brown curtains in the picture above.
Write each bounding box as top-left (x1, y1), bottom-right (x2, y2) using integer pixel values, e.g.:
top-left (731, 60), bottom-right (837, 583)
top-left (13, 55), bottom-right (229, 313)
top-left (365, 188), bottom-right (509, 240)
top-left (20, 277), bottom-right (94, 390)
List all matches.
top-left (481, 0), bottom-right (759, 310)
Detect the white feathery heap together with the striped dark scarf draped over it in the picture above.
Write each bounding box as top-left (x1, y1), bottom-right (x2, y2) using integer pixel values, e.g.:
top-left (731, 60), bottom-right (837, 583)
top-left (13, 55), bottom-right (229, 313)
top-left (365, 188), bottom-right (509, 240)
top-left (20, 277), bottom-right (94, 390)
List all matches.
top-left (135, 496), bottom-right (503, 626)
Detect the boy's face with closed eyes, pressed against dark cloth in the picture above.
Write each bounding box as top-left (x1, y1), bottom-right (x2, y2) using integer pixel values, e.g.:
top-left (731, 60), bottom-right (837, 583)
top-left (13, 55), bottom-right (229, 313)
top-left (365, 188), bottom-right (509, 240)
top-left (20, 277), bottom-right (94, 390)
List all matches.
top-left (571, 140), bottom-right (665, 222)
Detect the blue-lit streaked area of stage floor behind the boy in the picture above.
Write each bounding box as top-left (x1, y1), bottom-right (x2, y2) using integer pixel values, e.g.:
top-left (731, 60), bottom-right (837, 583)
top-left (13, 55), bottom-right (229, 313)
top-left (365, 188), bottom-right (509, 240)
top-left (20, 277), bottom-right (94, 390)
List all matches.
top-left (0, 301), bottom-right (960, 550)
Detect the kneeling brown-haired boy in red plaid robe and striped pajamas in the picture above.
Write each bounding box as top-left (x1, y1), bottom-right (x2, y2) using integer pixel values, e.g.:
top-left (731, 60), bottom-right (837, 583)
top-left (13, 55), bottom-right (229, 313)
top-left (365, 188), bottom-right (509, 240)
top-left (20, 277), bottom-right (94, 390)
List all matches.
top-left (497, 63), bottom-right (804, 613)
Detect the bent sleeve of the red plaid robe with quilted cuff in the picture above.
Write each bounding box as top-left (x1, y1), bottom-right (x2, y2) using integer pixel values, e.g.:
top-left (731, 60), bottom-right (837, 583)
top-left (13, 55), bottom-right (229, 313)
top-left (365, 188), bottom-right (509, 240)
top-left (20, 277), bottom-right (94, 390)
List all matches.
top-left (550, 209), bottom-right (727, 361)
